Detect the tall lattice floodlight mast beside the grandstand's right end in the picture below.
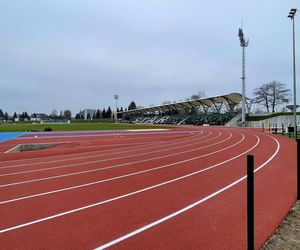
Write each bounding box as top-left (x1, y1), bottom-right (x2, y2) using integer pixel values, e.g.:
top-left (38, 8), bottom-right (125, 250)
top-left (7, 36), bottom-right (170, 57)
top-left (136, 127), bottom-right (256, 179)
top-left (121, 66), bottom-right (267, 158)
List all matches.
top-left (238, 29), bottom-right (249, 126)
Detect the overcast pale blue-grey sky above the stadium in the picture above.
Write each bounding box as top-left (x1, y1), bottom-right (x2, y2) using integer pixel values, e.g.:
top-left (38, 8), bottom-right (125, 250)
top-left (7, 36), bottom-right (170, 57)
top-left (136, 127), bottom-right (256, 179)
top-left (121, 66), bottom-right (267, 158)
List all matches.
top-left (0, 0), bottom-right (300, 113)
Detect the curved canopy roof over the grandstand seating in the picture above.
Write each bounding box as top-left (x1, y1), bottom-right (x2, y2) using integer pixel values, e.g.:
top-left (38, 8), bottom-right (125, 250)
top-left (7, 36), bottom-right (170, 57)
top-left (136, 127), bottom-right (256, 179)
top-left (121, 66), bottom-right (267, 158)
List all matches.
top-left (118, 93), bottom-right (242, 115)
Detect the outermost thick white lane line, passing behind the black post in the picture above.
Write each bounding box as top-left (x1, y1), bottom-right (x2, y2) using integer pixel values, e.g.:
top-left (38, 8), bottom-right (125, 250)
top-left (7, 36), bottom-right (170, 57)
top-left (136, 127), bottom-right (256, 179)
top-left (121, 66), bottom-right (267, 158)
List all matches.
top-left (96, 133), bottom-right (280, 250)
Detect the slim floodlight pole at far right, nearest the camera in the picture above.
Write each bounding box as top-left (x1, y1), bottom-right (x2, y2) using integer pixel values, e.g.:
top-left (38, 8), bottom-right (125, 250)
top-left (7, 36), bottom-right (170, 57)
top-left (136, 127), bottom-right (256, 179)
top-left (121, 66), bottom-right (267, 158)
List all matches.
top-left (288, 9), bottom-right (297, 140)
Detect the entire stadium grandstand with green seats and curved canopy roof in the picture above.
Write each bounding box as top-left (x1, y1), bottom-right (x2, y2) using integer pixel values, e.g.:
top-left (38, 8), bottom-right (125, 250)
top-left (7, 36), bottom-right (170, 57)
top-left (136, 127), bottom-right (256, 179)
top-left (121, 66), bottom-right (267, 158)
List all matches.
top-left (118, 93), bottom-right (242, 125)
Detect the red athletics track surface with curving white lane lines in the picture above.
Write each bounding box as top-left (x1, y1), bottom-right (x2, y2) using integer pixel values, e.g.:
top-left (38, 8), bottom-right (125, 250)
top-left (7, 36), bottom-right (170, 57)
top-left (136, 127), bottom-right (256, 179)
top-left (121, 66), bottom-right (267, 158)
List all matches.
top-left (0, 127), bottom-right (296, 249)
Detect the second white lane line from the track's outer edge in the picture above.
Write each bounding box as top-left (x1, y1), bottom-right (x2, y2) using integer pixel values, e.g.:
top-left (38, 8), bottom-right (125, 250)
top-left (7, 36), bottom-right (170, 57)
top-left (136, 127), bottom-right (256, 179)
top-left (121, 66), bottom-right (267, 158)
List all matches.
top-left (0, 135), bottom-right (260, 233)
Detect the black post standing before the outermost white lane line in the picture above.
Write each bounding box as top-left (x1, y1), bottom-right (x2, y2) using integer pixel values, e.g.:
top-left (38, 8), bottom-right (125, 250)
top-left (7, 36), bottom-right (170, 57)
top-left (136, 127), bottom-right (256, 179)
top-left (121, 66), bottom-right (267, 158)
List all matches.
top-left (247, 155), bottom-right (254, 250)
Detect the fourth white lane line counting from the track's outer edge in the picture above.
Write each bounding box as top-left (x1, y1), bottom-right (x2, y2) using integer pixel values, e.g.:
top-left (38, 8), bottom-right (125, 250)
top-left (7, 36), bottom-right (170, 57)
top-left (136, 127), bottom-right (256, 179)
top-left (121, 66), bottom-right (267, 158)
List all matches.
top-left (0, 132), bottom-right (232, 188)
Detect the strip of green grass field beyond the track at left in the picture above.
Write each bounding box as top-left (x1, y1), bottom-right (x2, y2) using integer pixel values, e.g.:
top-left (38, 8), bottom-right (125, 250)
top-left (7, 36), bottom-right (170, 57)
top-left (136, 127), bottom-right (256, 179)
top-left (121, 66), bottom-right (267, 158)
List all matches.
top-left (0, 123), bottom-right (170, 132)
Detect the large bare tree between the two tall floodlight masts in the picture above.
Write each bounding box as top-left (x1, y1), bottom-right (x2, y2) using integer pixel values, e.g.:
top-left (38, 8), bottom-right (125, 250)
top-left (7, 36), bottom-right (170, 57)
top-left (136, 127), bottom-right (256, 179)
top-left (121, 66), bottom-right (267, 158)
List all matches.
top-left (253, 81), bottom-right (291, 113)
